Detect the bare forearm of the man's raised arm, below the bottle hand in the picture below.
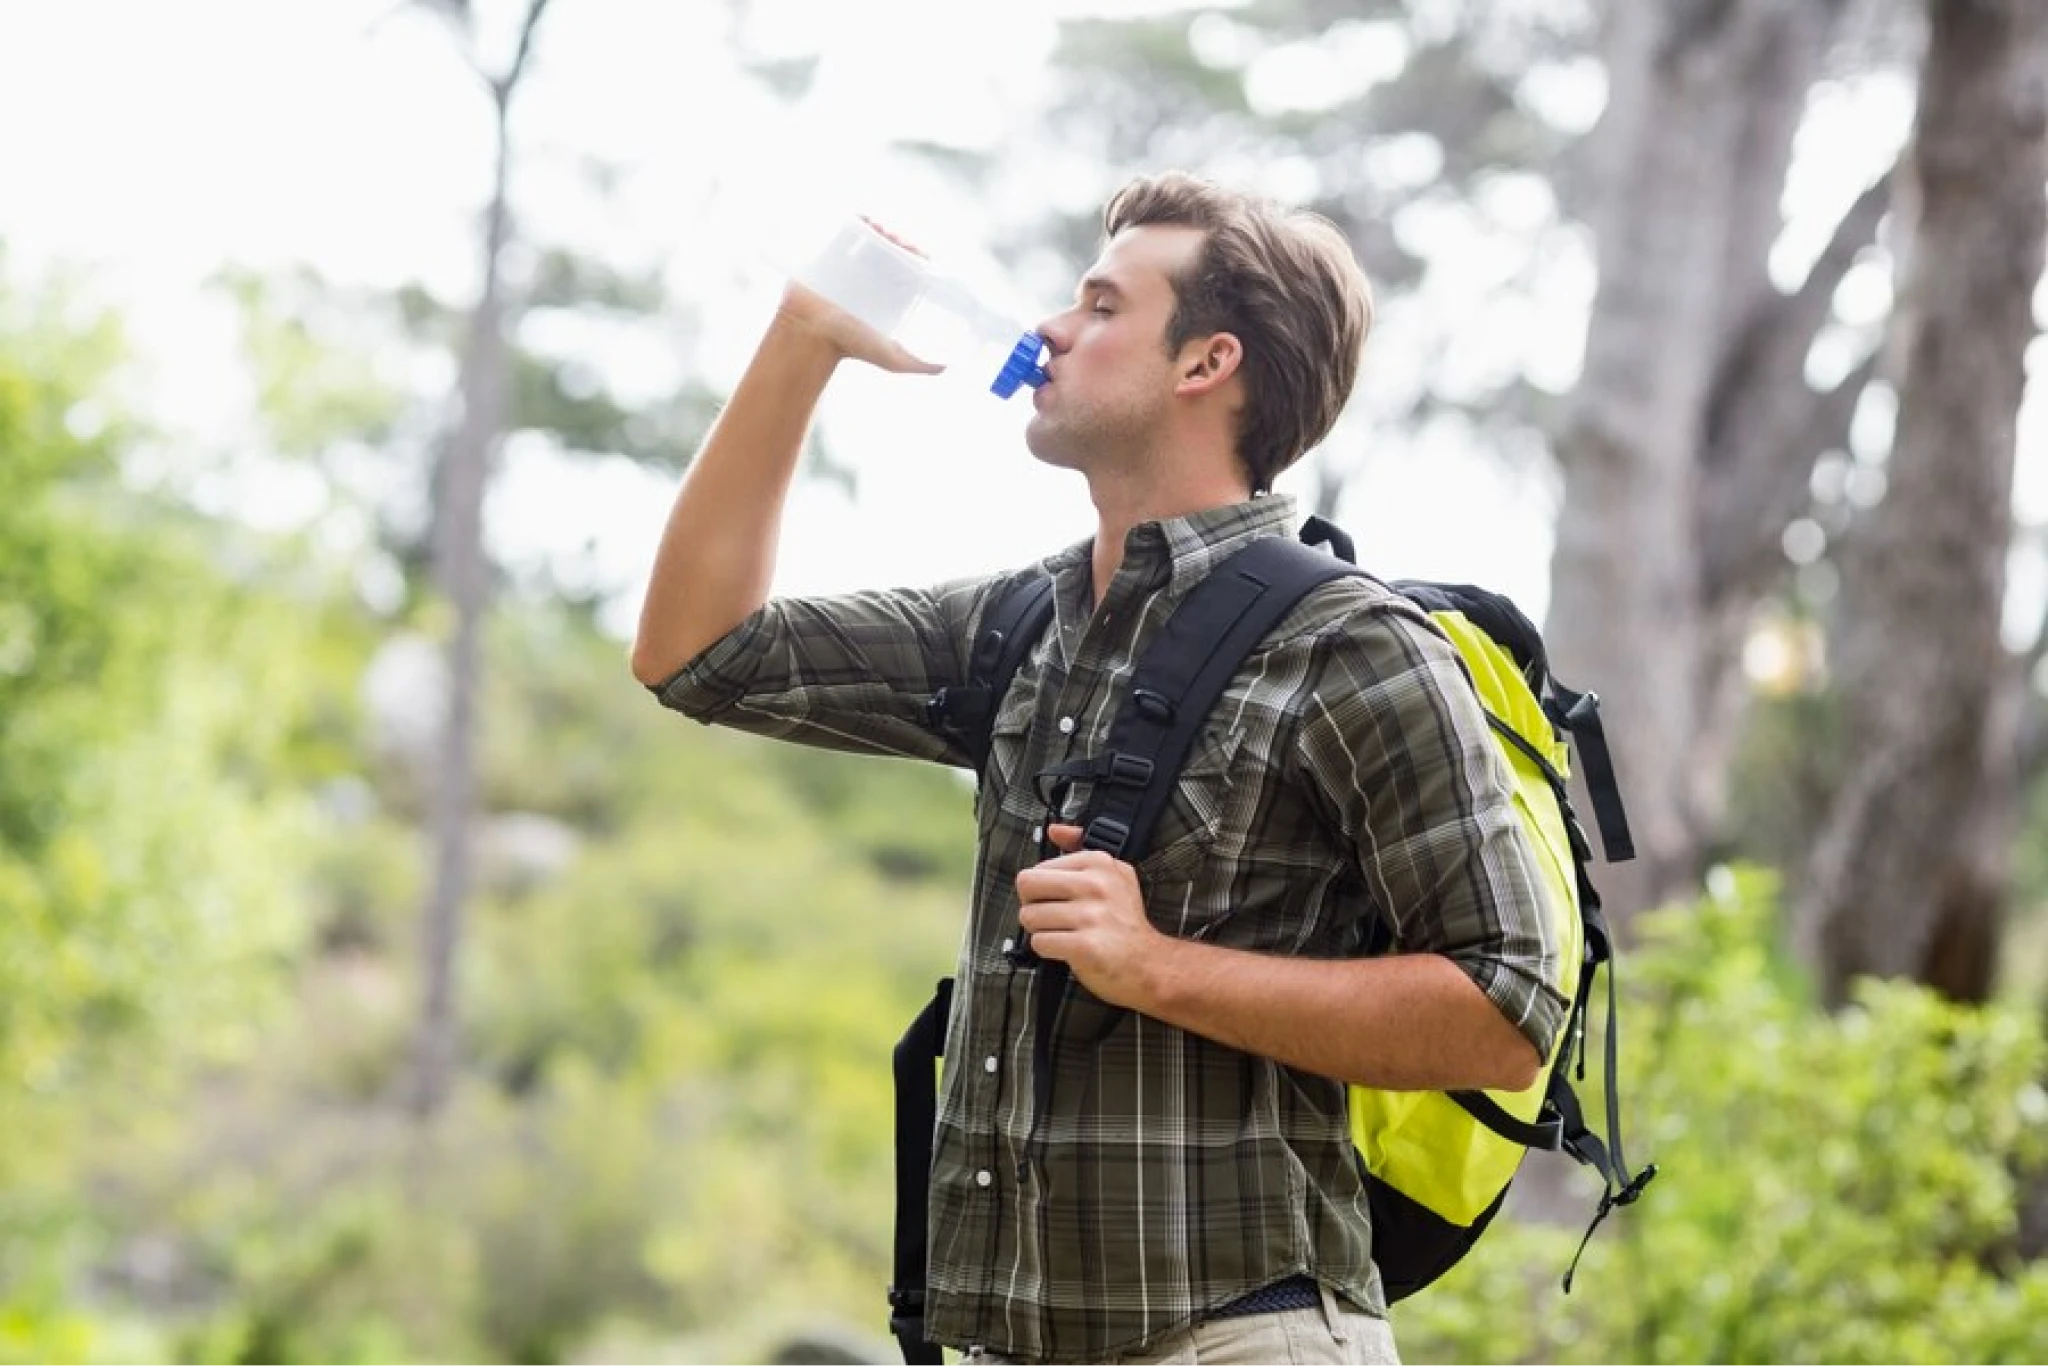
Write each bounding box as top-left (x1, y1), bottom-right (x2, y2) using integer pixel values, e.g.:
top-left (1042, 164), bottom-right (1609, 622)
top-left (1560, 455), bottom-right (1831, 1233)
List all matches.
top-left (633, 315), bottom-right (840, 686)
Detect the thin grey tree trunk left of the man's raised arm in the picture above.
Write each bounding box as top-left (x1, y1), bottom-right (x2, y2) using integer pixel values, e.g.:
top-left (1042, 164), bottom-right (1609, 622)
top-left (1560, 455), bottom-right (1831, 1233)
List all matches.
top-left (408, 0), bottom-right (549, 1118)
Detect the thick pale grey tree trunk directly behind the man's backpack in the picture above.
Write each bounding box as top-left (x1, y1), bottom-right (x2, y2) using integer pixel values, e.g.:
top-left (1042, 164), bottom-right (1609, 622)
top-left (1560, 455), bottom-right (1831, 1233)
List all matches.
top-left (1546, 0), bottom-right (1843, 932)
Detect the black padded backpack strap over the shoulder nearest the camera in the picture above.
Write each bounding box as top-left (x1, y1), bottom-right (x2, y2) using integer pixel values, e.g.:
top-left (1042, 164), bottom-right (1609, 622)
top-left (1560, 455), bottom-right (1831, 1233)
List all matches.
top-left (1081, 537), bottom-right (1356, 862)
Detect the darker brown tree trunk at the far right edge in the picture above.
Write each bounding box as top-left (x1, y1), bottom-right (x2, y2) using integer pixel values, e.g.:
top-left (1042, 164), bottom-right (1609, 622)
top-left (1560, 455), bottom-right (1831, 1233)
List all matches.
top-left (1798, 0), bottom-right (2048, 1004)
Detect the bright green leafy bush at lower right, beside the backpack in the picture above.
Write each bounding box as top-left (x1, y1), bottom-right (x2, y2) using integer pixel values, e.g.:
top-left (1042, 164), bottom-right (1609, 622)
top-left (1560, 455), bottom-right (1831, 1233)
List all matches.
top-left (1395, 872), bottom-right (2048, 1366)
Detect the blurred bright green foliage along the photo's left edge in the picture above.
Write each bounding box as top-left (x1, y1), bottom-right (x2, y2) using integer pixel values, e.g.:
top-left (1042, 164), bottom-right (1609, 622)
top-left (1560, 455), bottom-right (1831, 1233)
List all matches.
top-left (0, 286), bottom-right (323, 1196)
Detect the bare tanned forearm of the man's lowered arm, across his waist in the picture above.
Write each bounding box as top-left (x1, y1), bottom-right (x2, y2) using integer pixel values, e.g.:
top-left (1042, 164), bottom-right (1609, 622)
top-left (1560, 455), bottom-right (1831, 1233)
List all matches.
top-left (1133, 940), bottom-right (1542, 1092)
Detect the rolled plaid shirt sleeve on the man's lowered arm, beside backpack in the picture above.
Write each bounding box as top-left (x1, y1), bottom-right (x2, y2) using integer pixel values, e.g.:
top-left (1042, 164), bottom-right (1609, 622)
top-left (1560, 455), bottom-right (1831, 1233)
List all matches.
top-left (1296, 604), bottom-right (1567, 1057)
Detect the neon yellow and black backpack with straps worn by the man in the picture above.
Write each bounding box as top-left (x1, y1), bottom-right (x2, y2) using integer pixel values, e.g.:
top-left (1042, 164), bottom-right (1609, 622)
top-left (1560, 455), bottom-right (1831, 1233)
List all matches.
top-left (889, 518), bottom-right (1657, 1366)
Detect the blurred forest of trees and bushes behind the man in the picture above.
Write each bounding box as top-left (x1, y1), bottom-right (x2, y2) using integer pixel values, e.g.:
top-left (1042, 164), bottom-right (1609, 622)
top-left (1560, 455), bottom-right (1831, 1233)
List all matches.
top-left (12, 0), bottom-right (2048, 1366)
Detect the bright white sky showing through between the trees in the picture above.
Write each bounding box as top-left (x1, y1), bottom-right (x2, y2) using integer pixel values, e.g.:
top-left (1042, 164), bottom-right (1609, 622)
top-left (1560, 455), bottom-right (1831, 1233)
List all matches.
top-left (0, 0), bottom-right (2048, 643)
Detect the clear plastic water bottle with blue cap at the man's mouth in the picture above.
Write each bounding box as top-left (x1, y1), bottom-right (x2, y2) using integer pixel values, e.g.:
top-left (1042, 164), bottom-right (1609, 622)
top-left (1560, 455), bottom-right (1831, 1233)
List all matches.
top-left (793, 217), bottom-right (1047, 399)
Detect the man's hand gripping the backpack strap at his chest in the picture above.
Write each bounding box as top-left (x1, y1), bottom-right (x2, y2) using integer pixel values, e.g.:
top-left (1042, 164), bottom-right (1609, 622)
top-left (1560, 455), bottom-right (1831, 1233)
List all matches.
top-left (1018, 825), bottom-right (1174, 1010)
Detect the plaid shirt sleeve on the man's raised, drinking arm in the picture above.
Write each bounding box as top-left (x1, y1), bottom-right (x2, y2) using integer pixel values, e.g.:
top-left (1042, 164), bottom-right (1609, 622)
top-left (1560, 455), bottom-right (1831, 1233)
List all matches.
top-left (649, 580), bottom-right (1007, 766)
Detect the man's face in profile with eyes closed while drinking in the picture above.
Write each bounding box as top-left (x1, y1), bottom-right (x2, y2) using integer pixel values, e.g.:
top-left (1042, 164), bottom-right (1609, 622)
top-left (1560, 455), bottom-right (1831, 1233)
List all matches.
top-left (1024, 227), bottom-right (1202, 471)
